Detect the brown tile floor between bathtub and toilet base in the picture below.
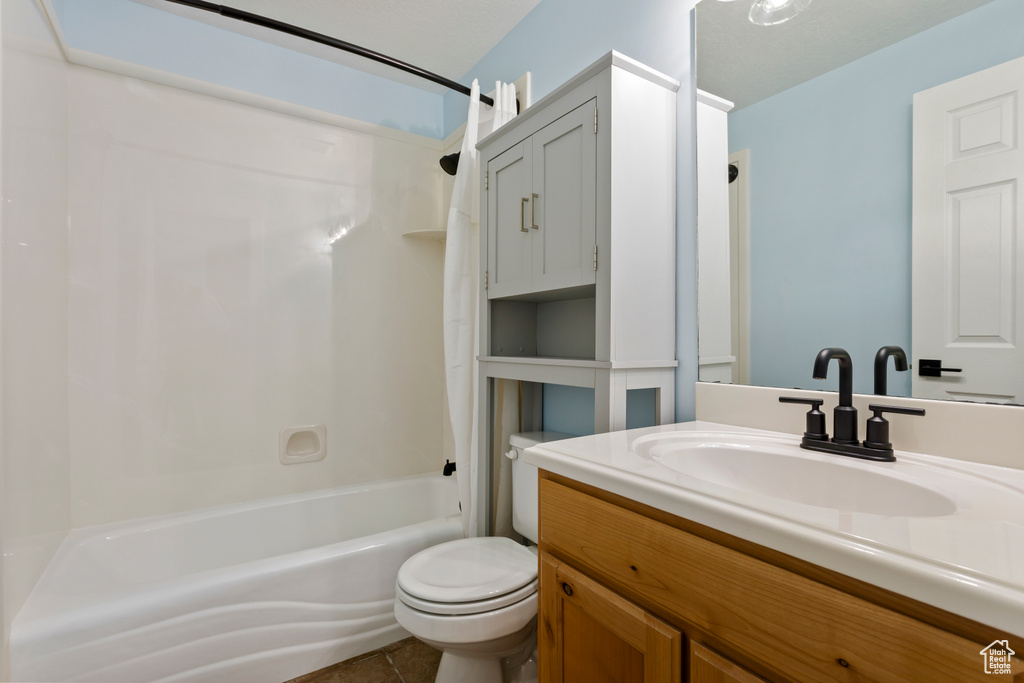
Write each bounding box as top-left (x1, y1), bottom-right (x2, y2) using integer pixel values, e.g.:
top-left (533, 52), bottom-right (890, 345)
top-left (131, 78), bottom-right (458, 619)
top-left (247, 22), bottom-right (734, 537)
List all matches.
top-left (287, 638), bottom-right (441, 683)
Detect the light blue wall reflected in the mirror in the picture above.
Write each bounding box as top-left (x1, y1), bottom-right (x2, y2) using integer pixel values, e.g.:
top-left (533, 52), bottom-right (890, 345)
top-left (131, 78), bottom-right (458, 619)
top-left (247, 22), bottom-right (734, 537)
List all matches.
top-left (729, 0), bottom-right (1024, 395)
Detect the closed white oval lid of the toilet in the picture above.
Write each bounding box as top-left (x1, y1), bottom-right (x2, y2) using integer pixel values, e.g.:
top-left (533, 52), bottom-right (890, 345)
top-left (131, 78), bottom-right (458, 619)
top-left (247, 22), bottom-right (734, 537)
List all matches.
top-left (398, 537), bottom-right (538, 603)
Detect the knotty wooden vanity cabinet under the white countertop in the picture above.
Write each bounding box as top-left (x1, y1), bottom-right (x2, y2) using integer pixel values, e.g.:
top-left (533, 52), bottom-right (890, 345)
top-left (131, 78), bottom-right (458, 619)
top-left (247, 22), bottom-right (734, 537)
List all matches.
top-left (539, 472), bottom-right (1024, 683)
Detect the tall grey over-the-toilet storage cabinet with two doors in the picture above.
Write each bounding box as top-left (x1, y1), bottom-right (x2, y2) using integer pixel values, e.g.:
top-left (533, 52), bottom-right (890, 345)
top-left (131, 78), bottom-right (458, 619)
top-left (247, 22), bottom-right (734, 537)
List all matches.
top-left (477, 52), bottom-right (679, 507)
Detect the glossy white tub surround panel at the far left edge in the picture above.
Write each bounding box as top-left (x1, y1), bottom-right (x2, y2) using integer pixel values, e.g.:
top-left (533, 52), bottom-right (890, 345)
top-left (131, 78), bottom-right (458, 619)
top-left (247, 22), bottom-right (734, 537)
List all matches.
top-left (0, 0), bottom-right (73, 663)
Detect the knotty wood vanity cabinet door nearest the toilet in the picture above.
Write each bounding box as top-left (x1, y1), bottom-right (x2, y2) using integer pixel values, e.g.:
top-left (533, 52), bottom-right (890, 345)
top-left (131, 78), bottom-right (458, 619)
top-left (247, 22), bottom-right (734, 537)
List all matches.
top-left (538, 552), bottom-right (683, 683)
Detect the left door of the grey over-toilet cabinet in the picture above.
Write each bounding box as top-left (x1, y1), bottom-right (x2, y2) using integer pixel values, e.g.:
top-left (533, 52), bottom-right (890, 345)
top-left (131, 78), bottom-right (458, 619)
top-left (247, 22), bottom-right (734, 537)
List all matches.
top-left (486, 140), bottom-right (532, 299)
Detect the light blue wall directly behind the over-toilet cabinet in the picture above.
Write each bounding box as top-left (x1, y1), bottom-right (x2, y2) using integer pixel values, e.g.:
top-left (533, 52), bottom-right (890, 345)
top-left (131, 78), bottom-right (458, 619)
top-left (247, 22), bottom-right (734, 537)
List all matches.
top-left (444, 0), bottom-right (697, 433)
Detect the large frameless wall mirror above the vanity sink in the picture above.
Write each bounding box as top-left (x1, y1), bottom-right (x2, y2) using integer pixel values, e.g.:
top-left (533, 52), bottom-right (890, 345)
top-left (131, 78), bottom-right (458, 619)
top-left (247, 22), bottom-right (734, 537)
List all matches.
top-left (696, 0), bottom-right (1024, 403)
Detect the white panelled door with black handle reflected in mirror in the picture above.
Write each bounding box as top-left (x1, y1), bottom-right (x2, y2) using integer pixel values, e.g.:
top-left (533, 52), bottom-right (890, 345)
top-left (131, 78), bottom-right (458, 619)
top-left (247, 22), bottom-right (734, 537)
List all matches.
top-left (911, 58), bottom-right (1024, 403)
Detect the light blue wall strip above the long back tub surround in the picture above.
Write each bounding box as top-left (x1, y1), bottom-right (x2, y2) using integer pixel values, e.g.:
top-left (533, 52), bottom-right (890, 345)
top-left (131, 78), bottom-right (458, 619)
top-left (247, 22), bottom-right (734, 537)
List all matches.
top-left (53, 0), bottom-right (444, 139)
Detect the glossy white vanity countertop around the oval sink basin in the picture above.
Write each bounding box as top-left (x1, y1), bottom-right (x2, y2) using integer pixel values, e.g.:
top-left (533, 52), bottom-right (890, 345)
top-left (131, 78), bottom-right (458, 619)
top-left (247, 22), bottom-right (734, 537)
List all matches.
top-left (523, 422), bottom-right (1024, 636)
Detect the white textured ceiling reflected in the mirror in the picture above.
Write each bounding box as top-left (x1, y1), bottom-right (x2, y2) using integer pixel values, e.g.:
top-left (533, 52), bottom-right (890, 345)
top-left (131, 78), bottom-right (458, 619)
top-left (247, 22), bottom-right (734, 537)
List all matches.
top-left (696, 0), bottom-right (991, 109)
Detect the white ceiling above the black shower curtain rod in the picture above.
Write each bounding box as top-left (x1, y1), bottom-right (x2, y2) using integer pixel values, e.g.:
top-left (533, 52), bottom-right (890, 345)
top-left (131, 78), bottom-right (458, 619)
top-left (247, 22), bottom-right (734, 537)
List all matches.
top-left (136, 0), bottom-right (541, 92)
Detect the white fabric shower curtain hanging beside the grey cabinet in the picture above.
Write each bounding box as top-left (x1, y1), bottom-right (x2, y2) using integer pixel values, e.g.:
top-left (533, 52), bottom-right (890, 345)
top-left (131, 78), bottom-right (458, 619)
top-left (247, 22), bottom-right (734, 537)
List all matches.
top-left (443, 80), bottom-right (515, 536)
